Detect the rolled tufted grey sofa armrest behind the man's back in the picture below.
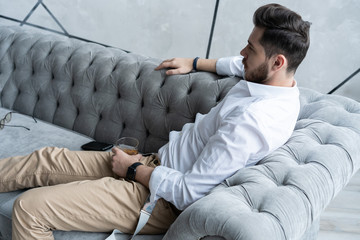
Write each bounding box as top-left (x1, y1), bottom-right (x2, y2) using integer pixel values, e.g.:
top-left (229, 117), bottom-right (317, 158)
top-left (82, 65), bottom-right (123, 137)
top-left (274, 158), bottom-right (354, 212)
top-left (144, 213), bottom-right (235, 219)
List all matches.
top-left (164, 89), bottom-right (360, 240)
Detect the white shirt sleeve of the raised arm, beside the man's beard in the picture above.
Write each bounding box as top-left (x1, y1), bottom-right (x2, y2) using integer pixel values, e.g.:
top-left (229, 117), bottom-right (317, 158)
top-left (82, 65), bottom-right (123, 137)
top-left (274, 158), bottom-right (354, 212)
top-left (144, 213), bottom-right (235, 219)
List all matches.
top-left (216, 56), bottom-right (244, 77)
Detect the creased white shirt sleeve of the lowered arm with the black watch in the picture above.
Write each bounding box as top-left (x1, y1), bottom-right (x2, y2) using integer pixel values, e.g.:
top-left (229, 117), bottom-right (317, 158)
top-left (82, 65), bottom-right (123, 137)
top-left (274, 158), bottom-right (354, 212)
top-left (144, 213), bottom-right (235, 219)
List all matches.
top-left (149, 107), bottom-right (266, 210)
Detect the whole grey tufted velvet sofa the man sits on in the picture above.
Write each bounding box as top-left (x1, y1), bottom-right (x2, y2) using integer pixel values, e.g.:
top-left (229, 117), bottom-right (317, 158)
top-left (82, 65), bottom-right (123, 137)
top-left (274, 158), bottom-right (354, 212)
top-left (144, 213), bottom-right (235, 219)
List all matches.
top-left (0, 26), bottom-right (360, 240)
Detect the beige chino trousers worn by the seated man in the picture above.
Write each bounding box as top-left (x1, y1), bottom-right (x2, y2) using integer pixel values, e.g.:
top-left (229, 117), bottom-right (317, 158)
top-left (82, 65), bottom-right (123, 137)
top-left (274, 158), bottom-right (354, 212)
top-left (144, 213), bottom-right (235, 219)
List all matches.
top-left (0, 147), bottom-right (177, 240)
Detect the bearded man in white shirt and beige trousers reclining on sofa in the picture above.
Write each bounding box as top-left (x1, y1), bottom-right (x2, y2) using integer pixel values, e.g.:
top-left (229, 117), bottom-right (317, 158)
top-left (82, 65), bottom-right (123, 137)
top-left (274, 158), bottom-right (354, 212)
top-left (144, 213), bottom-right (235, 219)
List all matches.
top-left (0, 4), bottom-right (310, 239)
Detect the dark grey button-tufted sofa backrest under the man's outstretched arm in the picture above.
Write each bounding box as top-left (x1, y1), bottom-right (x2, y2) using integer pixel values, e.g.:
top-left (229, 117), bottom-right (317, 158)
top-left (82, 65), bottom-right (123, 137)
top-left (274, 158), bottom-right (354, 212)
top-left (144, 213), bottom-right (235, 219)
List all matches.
top-left (0, 27), bottom-right (238, 152)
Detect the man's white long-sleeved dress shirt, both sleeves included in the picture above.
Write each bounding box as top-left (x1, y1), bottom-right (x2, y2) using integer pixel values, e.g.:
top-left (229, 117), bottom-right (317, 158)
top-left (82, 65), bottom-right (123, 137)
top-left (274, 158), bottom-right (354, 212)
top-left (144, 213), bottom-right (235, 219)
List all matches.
top-left (149, 57), bottom-right (300, 210)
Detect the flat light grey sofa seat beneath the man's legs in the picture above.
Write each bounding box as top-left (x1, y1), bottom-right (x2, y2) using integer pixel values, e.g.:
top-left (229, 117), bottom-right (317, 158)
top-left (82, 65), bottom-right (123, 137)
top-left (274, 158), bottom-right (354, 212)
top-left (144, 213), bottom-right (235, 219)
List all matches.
top-left (0, 108), bottom-right (162, 240)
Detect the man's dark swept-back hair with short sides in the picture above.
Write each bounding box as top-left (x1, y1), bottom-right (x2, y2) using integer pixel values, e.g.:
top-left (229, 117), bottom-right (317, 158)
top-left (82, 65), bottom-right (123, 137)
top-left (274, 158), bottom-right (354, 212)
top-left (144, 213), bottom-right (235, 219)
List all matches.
top-left (253, 4), bottom-right (310, 73)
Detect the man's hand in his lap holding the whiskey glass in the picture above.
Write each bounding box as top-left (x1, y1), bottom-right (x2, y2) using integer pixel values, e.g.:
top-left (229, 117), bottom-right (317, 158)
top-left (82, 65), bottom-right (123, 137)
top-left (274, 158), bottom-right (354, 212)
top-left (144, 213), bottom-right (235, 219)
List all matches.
top-left (111, 147), bottom-right (142, 178)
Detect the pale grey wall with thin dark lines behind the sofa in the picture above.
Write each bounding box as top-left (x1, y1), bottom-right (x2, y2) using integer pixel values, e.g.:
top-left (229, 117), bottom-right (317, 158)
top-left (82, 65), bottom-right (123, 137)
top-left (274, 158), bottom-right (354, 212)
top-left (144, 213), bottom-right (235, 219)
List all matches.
top-left (0, 0), bottom-right (360, 101)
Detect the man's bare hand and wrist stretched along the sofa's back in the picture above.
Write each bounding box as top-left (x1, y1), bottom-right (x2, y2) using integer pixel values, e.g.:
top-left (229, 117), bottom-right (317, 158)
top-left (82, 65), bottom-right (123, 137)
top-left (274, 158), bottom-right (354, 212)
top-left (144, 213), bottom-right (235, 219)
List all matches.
top-left (155, 58), bottom-right (217, 75)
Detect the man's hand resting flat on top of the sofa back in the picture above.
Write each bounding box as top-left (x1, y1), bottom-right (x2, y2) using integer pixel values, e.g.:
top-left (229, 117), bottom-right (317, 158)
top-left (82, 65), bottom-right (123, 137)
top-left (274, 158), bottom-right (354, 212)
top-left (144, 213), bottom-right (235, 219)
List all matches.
top-left (155, 58), bottom-right (193, 75)
